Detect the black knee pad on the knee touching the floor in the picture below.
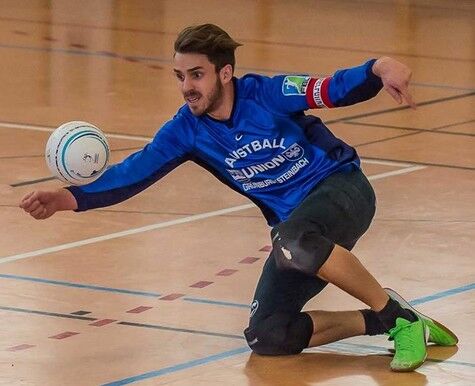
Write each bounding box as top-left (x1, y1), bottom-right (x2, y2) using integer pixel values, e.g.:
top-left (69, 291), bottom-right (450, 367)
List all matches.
top-left (244, 312), bottom-right (313, 355)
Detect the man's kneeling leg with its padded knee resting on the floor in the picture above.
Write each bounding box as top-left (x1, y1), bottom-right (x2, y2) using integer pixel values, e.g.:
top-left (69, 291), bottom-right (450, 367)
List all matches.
top-left (244, 250), bottom-right (385, 355)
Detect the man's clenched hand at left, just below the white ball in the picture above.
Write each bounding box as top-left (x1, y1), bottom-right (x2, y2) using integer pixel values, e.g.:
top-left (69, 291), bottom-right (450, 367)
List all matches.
top-left (19, 189), bottom-right (77, 220)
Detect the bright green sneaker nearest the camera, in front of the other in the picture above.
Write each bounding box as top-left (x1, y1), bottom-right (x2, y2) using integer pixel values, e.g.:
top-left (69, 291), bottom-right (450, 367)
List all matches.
top-left (389, 318), bottom-right (427, 371)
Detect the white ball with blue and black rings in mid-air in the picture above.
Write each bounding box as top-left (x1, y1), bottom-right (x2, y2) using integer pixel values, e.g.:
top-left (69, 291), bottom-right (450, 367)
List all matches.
top-left (45, 121), bottom-right (110, 185)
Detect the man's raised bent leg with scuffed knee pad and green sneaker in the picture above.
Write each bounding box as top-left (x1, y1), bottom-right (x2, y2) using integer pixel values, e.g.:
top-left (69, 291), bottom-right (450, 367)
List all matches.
top-left (272, 171), bottom-right (426, 371)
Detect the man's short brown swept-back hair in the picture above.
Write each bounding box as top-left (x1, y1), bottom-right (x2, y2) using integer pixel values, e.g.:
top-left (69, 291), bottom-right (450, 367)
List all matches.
top-left (175, 24), bottom-right (242, 72)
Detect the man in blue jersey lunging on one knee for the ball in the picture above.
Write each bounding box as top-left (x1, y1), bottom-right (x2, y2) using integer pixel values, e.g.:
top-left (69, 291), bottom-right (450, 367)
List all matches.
top-left (20, 24), bottom-right (457, 371)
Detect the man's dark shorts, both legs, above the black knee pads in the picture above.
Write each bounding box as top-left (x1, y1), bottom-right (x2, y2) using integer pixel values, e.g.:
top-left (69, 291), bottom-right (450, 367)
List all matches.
top-left (250, 168), bottom-right (376, 327)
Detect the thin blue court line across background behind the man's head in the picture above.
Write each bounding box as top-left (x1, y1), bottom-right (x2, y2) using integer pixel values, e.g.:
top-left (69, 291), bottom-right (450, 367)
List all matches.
top-left (0, 44), bottom-right (475, 91)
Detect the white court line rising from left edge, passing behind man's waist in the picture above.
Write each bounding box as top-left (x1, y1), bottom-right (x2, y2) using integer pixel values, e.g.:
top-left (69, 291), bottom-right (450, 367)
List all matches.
top-left (0, 166), bottom-right (427, 264)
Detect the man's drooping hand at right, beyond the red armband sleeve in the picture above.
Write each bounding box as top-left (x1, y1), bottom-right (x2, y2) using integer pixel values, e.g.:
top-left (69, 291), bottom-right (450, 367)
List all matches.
top-left (372, 56), bottom-right (416, 109)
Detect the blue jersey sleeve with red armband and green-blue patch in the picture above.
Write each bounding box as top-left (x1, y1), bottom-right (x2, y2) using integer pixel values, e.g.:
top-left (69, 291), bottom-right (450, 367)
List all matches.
top-left (251, 59), bottom-right (383, 114)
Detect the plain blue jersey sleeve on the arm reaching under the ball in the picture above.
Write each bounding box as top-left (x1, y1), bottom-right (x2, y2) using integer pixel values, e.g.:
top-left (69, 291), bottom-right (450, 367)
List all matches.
top-left (66, 120), bottom-right (194, 211)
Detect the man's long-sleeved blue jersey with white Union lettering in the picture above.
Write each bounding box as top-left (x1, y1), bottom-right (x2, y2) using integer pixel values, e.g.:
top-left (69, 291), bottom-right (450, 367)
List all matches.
top-left (68, 60), bottom-right (382, 225)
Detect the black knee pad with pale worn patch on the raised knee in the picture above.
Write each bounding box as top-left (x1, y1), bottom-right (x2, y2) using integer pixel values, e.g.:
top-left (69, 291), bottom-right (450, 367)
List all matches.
top-left (271, 220), bottom-right (335, 276)
